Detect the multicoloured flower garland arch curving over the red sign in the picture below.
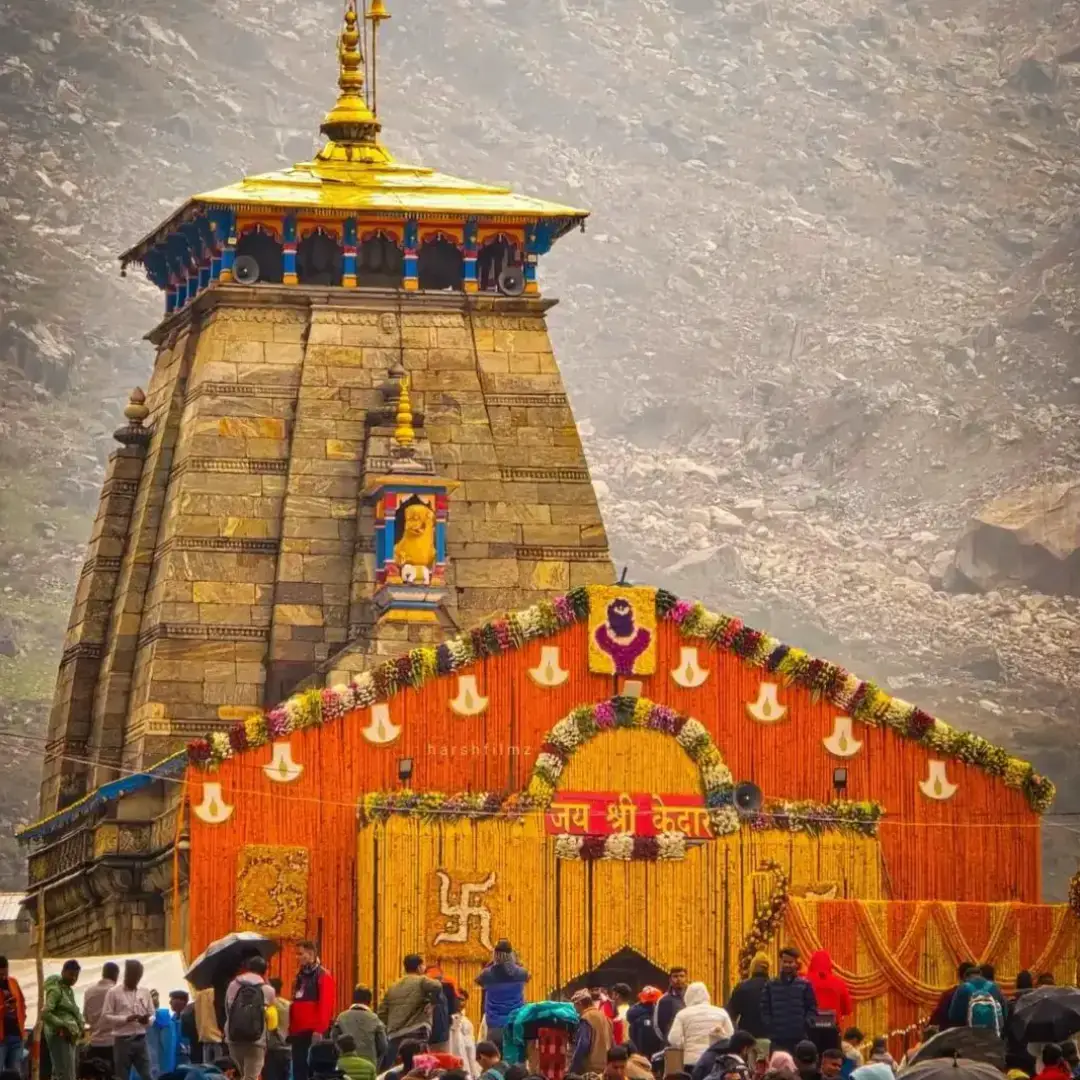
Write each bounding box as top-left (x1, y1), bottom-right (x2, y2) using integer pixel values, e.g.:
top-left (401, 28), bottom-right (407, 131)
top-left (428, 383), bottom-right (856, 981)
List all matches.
top-left (525, 697), bottom-right (739, 836)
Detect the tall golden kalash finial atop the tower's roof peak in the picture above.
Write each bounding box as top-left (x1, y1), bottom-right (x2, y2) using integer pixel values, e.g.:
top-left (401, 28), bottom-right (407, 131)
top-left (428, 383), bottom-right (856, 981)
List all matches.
top-left (316, 0), bottom-right (392, 165)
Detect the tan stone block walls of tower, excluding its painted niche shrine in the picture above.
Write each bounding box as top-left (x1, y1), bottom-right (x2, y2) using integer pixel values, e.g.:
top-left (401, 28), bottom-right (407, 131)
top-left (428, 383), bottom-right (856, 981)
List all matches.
top-left (42, 285), bottom-right (613, 812)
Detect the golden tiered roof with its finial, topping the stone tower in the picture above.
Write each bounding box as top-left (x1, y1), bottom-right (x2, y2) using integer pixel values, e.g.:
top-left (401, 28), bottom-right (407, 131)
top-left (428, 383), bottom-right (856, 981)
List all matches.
top-left (121, 0), bottom-right (589, 264)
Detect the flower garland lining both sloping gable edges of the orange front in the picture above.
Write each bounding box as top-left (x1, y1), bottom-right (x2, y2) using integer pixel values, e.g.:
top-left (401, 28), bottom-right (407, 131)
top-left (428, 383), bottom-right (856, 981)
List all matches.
top-left (188, 585), bottom-right (1055, 813)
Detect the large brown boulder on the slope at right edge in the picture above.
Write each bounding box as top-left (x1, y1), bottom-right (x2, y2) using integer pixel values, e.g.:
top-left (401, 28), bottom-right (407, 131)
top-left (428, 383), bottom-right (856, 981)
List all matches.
top-left (955, 484), bottom-right (1080, 596)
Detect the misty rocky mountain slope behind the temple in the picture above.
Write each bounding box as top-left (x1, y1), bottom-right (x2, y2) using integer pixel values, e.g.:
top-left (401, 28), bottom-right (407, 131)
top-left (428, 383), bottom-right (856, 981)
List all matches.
top-left (0, 0), bottom-right (1080, 897)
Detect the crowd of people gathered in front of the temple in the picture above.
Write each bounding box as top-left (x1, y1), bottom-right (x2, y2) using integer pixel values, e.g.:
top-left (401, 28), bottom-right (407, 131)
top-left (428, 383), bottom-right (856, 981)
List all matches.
top-left (0, 941), bottom-right (1080, 1080)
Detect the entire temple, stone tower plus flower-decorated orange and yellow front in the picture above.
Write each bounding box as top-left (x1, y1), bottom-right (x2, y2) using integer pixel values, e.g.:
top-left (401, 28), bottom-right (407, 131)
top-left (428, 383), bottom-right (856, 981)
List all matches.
top-left (14, 0), bottom-right (1080, 1045)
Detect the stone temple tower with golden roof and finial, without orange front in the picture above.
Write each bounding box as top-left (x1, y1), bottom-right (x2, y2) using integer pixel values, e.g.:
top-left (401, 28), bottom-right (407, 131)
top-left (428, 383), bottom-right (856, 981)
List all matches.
top-left (22, 0), bottom-right (613, 955)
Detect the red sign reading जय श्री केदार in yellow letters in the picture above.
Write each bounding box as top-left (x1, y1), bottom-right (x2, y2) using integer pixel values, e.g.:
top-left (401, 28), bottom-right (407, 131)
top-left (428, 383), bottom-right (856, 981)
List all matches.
top-left (544, 792), bottom-right (713, 838)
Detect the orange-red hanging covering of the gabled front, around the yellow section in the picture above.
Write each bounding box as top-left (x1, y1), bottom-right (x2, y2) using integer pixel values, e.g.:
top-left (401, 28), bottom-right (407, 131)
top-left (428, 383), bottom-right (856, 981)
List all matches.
top-left (188, 623), bottom-right (1053, 1006)
